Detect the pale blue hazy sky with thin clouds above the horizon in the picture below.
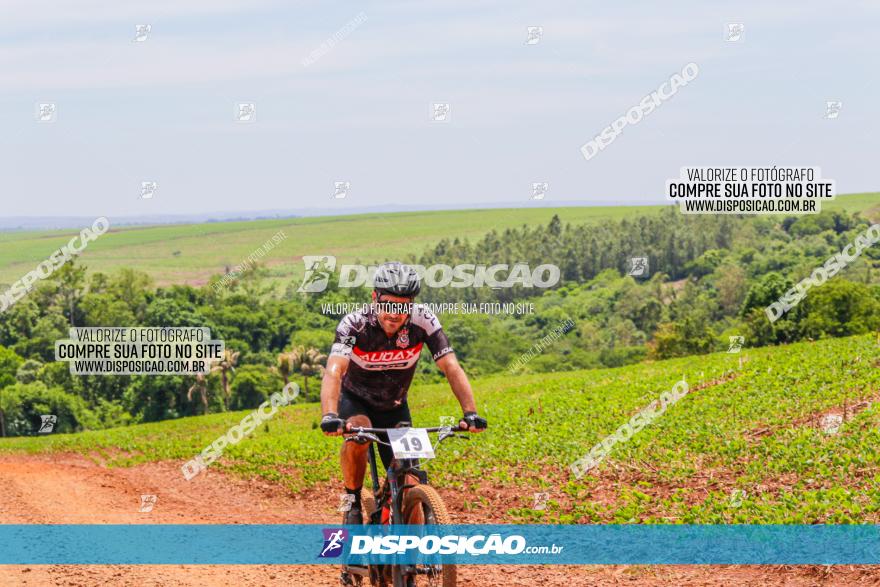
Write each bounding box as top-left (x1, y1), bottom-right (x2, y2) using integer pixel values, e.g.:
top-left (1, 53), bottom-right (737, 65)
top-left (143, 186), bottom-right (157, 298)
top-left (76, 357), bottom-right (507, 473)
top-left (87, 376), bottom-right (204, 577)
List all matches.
top-left (0, 0), bottom-right (880, 217)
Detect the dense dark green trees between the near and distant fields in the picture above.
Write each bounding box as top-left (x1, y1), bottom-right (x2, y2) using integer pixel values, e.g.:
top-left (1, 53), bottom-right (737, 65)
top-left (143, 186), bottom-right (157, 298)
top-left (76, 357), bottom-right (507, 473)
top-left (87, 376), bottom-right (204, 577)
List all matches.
top-left (0, 211), bottom-right (880, 435)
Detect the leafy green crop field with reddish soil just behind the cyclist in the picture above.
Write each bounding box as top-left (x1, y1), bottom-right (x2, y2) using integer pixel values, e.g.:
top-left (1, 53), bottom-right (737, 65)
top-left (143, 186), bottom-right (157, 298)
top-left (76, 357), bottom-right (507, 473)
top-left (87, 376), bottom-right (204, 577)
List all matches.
top-left (0, 335), bottom-right (880, 523)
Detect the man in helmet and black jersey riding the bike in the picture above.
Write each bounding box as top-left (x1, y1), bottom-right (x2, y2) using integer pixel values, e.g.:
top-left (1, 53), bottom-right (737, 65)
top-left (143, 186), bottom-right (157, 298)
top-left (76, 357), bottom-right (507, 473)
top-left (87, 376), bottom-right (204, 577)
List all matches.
top-left (321, 262), bottom-right (486, 524)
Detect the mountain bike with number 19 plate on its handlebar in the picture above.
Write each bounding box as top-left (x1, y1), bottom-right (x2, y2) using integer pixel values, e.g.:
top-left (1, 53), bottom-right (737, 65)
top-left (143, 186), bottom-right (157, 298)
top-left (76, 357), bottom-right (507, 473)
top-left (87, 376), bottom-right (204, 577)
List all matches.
top-left (343, 426), bottom-right (469, 587)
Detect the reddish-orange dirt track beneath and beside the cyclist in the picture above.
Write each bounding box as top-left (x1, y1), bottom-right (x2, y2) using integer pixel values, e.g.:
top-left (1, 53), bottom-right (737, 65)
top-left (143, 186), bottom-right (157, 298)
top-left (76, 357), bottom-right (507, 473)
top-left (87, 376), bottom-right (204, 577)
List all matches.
top-left (0, 455), bottom-right (880, 587)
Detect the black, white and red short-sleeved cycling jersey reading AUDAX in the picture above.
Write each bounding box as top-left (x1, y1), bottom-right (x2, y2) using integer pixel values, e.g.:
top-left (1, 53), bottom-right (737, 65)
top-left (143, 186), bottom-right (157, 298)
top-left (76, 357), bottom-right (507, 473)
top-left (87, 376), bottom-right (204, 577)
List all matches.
top-left (330, 304), bottom-right (453, 410)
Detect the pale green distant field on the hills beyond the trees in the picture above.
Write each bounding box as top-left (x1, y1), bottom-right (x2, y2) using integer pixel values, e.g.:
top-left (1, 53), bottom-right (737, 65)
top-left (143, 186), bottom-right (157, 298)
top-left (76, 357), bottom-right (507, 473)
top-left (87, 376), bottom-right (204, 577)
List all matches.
top-left (0, 193), bottom-right (880, 285)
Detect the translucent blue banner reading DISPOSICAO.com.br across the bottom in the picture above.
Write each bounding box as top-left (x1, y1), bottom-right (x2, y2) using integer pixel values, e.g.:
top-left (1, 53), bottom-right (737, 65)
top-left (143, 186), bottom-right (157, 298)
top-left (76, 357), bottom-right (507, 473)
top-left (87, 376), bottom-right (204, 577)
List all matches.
top-left (0, 524), bottom-right (880, 565)
